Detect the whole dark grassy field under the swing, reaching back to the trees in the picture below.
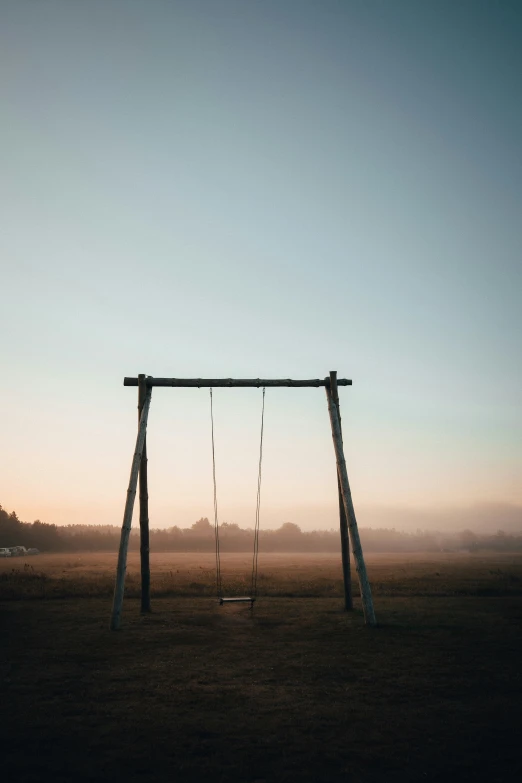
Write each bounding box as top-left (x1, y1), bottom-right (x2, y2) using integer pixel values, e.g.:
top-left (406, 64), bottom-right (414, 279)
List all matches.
top-left (0, 553), bottom-right (522, 783)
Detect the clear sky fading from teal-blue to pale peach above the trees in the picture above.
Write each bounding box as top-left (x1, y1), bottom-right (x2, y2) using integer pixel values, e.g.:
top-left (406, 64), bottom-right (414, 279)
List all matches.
top-left (0, 0), bottom-right (522, 529)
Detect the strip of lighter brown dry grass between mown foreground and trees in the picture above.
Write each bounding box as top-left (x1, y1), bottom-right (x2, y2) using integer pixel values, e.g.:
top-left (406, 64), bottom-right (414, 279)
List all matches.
top-left (0, 553), bottom-right (522, 599)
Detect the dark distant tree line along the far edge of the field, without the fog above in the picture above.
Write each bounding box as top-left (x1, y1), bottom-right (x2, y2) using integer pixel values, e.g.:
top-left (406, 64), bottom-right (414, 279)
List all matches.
top-left (0, 506), bottom-right (522, 552)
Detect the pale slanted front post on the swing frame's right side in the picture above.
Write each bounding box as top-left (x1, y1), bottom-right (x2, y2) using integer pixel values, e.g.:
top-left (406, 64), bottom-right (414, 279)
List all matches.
top-left (325, 384), bottom-right (377, 625)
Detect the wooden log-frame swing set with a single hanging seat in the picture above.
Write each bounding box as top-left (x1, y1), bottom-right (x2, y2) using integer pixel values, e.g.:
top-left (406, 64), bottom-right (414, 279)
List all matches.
top-left (110, 371), bottom-right (376, 631)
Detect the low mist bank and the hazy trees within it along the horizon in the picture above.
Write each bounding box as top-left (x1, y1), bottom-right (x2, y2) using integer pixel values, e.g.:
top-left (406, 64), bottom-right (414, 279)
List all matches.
top-left (0, 506), bottom-right (522, 554)
